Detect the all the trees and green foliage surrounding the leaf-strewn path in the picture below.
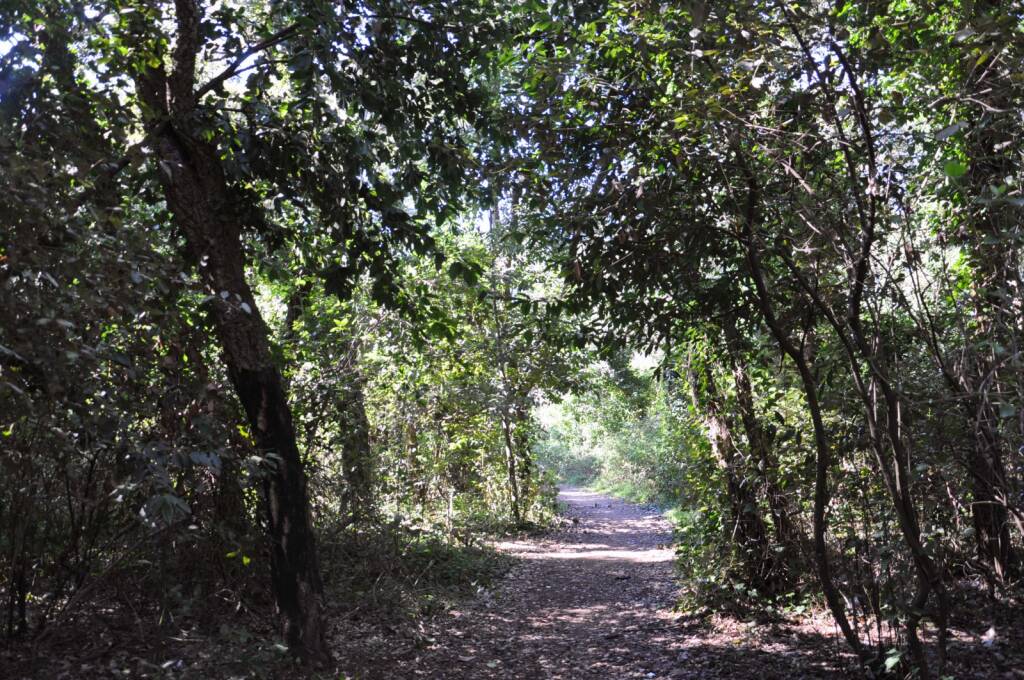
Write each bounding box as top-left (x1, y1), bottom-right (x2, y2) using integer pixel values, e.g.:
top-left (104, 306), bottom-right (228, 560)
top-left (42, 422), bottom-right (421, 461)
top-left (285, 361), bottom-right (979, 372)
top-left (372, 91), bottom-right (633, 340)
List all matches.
top-left (0, 0), bottom-right (1024, 677)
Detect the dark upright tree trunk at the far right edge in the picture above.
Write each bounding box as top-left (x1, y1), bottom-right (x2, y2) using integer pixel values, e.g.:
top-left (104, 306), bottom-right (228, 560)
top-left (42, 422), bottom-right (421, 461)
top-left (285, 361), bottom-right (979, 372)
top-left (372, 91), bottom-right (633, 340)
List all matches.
top-left (958, 0), bottom-right (1024, 583)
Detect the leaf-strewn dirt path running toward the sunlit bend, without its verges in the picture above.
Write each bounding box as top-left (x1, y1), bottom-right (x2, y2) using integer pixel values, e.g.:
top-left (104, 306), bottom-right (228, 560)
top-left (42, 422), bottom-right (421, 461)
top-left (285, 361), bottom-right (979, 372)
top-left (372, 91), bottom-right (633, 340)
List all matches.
top-left (419, 488), bottom-right (679, 678)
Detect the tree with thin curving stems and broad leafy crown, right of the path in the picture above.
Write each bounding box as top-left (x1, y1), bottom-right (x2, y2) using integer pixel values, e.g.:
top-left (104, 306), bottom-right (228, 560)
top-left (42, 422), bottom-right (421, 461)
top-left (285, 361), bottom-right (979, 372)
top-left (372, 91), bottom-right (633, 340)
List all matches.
top-left (508, 2), bottom-right (1007, 675)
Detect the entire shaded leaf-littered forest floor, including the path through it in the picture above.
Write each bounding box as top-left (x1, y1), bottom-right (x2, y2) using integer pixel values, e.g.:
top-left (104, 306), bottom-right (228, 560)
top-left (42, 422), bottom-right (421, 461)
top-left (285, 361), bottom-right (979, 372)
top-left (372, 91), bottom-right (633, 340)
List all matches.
top-left (9, 488), bottom-right (1024, 680)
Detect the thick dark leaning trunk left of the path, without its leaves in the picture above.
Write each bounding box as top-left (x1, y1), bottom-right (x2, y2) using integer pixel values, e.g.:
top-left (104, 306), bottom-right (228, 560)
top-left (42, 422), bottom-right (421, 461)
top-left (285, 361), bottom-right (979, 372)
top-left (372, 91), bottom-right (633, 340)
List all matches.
top-left (138, 49), bottom-right (329, 662)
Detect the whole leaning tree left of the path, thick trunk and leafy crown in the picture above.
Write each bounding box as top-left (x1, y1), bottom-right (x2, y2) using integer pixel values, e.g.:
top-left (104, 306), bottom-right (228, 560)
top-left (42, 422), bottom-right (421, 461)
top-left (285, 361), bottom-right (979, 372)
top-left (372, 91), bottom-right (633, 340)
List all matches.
top-left (1, 0), bottom-right (497, 661)
